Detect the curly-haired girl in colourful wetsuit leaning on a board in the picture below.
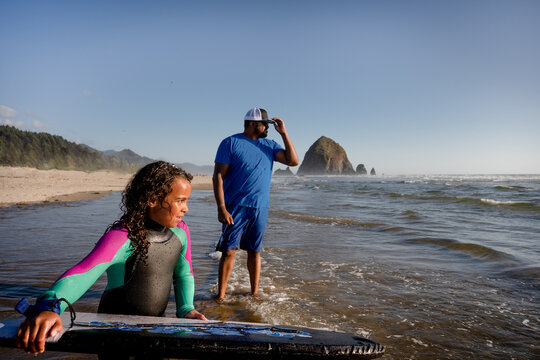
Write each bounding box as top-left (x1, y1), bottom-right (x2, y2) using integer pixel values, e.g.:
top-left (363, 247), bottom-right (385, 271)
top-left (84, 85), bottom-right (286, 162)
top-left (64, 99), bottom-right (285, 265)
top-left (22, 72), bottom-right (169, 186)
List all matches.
top-left (17, 161), bottom-right (206, 354)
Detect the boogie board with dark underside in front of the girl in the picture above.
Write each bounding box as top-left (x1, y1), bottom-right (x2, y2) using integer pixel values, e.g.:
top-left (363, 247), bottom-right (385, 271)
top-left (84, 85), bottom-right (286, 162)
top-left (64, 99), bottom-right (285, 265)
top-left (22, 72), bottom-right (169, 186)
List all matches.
top-left (0, 312), bottom-right (384, 359)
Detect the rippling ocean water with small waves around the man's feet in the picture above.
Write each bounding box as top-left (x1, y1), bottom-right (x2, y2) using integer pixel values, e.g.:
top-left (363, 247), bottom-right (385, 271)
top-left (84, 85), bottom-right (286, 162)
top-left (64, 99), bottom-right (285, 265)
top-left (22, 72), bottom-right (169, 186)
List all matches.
top-left (0, 175), bottom-right (540, 359)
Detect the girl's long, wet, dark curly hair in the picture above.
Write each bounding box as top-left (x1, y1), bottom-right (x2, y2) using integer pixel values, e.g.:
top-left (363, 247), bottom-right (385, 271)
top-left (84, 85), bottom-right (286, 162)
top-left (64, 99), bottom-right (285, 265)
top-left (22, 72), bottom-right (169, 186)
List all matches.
top-left (107, 161), bottom-right (193, 259)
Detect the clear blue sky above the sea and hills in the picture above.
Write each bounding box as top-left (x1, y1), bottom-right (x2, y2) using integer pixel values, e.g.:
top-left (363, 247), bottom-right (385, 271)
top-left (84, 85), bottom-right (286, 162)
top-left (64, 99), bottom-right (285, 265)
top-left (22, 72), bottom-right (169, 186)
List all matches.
top-left (0, 0), bottom-right (540, 174)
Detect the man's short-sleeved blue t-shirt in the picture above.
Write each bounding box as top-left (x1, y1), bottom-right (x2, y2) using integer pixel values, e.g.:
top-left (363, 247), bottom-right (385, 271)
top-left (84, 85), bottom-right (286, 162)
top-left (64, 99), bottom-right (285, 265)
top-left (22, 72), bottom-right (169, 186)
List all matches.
top-left (215, 134), bottom-right (283, 208)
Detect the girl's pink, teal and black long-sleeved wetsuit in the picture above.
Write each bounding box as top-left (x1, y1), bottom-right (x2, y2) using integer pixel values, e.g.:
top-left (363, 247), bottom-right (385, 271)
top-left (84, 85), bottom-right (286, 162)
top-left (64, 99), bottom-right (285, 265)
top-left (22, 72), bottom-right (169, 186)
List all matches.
top-left (34, 221), bottom-right (195, 317)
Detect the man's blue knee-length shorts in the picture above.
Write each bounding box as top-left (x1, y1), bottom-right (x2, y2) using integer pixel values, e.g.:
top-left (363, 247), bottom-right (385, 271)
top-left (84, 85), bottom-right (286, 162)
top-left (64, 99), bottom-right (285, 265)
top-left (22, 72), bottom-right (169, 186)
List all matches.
top-left (216, 205), bottom-right (268, 251)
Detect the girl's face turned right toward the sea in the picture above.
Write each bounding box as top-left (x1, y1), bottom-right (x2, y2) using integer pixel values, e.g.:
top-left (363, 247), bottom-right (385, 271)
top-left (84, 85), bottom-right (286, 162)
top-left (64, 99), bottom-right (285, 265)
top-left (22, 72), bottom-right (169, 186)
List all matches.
top-left (148, 177), bottom-right (191, 228)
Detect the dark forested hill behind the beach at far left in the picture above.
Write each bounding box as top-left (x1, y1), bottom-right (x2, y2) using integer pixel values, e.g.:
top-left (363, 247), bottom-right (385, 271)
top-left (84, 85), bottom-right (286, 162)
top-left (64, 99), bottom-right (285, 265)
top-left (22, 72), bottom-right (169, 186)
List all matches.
top-left (0, 125), bottom-right (153, 172)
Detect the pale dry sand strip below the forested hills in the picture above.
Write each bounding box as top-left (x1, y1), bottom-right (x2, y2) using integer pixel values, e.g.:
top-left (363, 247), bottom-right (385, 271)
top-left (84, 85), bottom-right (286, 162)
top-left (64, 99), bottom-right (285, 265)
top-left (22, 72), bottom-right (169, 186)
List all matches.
top-left (0, 167), bottom-right (212, 206)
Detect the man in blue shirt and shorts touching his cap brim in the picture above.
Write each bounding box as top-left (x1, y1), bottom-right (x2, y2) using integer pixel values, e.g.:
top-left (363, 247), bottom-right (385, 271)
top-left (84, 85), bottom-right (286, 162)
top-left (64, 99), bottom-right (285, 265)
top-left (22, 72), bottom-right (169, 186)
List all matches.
top-left (212, 108), bottom-right (298, 301)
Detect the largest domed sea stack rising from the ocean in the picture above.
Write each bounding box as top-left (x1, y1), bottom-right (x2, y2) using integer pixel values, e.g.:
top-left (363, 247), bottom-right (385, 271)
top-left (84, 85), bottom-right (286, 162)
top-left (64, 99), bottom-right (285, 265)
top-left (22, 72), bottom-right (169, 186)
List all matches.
top-left (297, 136), bottom-right (355, 175)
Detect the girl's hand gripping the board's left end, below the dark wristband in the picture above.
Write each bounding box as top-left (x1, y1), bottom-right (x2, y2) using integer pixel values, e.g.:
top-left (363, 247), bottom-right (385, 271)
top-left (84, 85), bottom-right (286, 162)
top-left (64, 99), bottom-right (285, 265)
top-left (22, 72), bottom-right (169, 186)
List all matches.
top-left (15, 311), bottom-right (63, 354)
